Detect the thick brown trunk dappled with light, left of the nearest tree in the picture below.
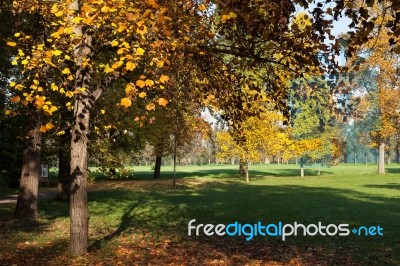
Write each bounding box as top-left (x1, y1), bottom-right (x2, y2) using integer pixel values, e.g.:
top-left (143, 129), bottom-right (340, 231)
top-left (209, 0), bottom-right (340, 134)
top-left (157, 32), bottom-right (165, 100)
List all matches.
top-left (14, 107), bottom-right (42, 220)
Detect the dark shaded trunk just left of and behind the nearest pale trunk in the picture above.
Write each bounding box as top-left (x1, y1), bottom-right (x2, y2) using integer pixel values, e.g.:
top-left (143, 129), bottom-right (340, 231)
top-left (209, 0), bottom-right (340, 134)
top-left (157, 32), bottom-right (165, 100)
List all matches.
top-left (55, 128), bottom-right (71, 201)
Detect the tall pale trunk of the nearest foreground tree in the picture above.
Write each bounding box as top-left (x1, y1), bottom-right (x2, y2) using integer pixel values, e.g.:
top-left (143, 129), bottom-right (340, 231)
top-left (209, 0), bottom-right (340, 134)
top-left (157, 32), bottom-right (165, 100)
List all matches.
top-left (68, 0), bottom-right (99, 256)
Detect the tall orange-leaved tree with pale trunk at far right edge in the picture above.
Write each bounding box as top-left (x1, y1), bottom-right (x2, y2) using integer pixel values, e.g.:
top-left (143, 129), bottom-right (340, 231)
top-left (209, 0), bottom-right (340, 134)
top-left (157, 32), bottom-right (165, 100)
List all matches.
top-left (342, 1), bottom-right (399, 174)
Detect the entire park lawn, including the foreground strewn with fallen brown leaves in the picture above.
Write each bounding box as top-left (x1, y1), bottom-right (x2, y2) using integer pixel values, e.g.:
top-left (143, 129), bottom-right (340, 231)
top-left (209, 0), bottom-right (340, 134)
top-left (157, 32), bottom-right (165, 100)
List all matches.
top-left (0, 165), bottom-right (400, 265)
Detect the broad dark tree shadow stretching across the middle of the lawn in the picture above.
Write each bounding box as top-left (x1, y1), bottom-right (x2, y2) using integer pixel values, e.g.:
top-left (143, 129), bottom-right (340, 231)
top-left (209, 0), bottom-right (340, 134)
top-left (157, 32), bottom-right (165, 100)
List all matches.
top-left (86, 182), bottom-right (400, 264)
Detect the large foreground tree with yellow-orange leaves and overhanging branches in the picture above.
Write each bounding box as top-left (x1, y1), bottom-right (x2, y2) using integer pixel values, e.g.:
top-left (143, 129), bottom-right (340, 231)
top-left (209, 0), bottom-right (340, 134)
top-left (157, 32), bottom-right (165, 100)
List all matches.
top-left (4, 0), bottom-right (348, 255)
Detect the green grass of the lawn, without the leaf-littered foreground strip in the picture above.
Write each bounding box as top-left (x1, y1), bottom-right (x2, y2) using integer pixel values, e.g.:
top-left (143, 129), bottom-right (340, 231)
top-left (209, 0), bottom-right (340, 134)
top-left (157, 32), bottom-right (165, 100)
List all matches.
top-left (0, 165), bottom-right (400, 265)
